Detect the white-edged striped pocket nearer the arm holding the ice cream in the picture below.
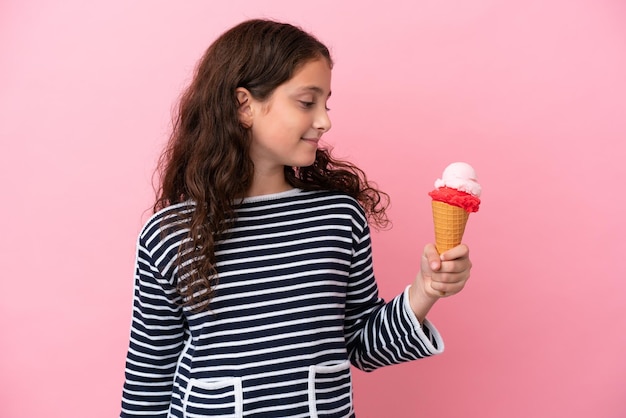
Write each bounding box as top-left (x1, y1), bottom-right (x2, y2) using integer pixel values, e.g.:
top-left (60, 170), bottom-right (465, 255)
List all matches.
top-left (308, 360), bottom-right (353, 418)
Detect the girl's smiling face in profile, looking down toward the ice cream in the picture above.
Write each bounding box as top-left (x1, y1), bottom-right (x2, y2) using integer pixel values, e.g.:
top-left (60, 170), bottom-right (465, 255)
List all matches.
top-left (245, 59), bottom-right (331, 170)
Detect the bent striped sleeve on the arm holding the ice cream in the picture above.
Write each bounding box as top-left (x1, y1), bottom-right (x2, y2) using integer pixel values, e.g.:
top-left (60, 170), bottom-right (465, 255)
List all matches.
top-left (345, 220), bottom-right (443, 371)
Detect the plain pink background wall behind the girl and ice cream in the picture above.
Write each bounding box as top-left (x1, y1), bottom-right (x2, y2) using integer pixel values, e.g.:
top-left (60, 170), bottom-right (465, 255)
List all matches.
top-left (0, 0), bottom-right (626, 418)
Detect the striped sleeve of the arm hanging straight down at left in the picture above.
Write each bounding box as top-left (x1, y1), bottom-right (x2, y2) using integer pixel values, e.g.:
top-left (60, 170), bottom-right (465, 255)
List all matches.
top-left (121, 226), bottom-right (186, 417)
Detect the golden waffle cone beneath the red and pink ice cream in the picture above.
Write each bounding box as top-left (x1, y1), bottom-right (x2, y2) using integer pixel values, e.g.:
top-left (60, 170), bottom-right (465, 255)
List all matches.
top-left (432, 200), bottom-right (469, 254)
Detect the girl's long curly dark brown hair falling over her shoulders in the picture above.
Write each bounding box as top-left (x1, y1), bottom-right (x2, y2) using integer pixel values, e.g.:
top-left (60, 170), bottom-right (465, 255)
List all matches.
top-left (153, 19), bottom-right (389, 310)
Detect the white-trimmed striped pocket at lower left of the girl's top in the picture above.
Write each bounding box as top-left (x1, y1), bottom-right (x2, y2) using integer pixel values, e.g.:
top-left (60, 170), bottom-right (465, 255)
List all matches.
top-left (183, 377), bottom-right (243, 418)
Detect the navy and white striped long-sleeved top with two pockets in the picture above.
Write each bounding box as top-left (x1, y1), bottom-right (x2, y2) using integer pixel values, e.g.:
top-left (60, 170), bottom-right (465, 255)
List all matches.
top-left (121, 189), bottom-right (443, 418)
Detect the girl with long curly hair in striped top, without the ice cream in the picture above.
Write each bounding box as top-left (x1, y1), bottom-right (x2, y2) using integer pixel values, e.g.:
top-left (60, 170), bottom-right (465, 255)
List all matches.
top-left (121, 20), bottom-right (471, 417)
